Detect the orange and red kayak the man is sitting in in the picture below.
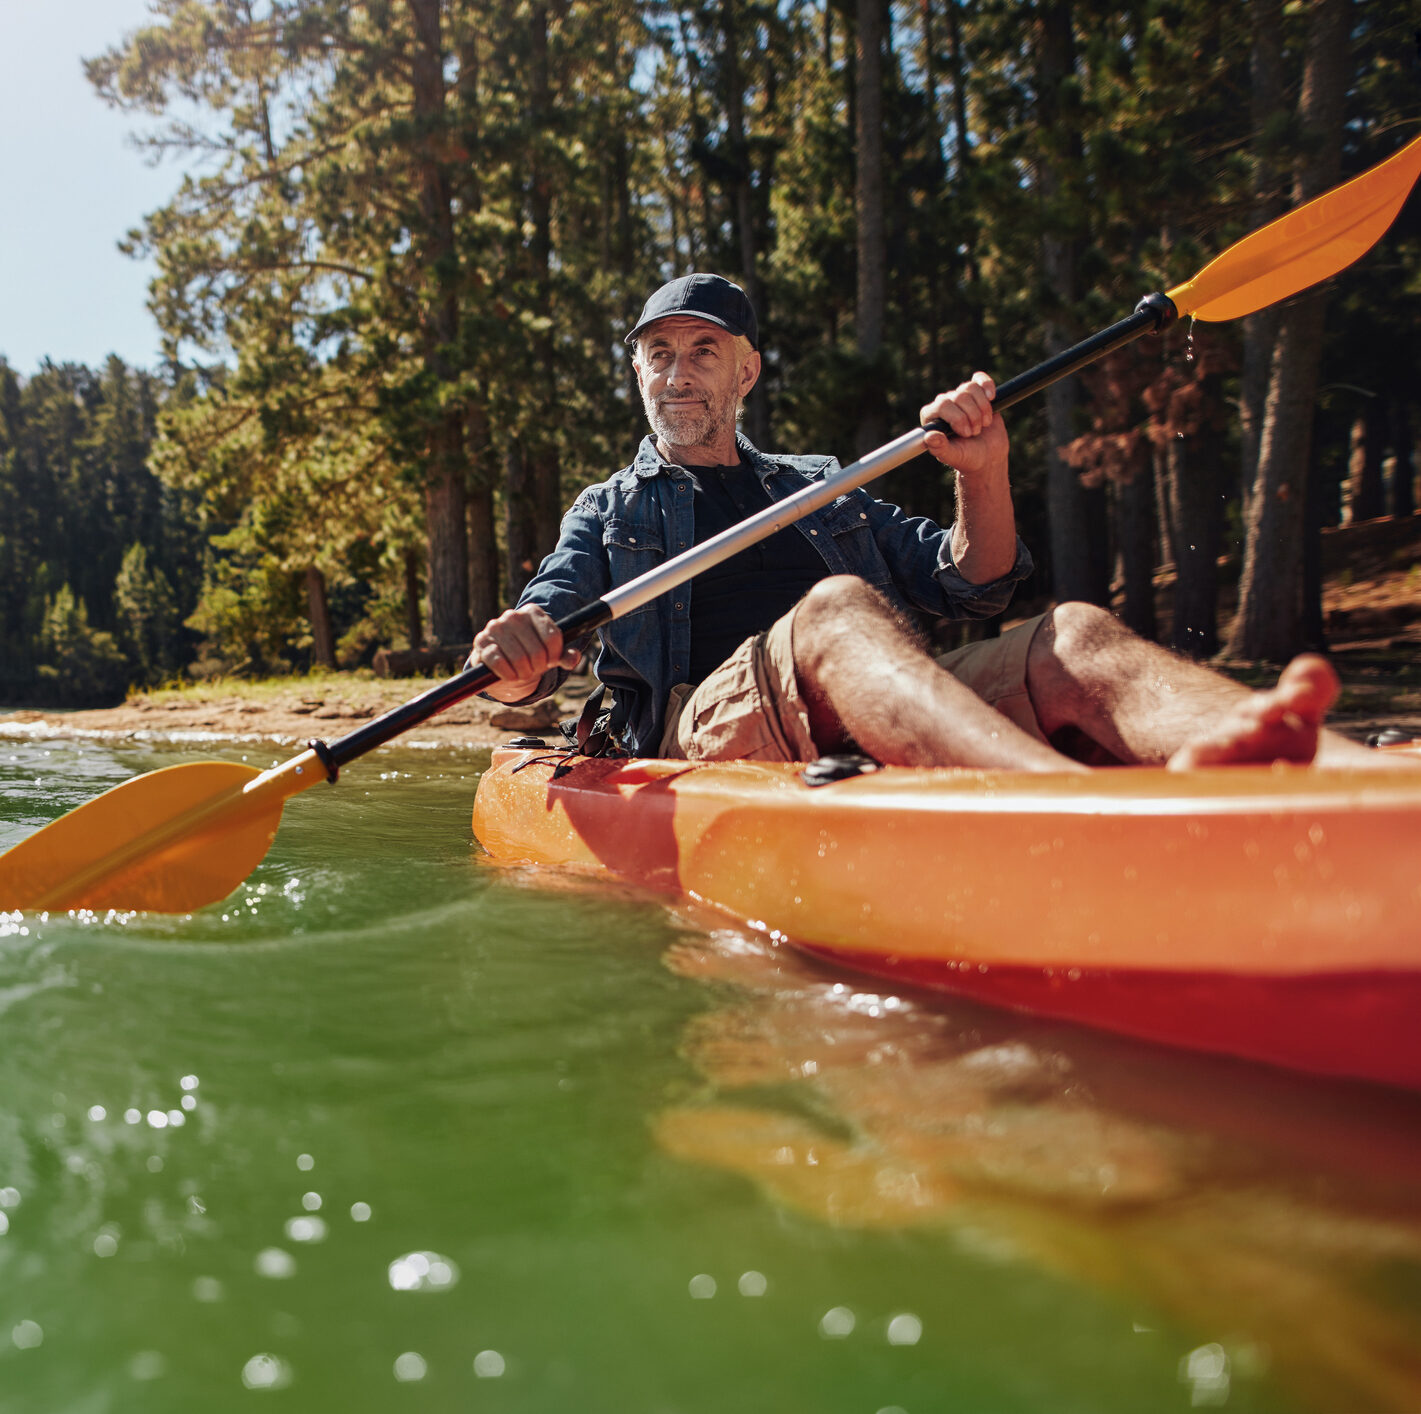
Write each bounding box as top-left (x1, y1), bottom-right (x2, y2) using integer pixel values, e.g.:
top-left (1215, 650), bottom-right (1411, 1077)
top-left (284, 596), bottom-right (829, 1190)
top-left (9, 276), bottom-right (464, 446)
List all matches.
top-left (473, 745), bottom-right (1421, 1089)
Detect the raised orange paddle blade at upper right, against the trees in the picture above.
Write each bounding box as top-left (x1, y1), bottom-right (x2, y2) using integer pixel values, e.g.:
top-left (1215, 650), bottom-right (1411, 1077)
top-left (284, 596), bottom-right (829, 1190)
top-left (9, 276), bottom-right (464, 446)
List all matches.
top-left (1169, 138), bottom-right (1421, 321)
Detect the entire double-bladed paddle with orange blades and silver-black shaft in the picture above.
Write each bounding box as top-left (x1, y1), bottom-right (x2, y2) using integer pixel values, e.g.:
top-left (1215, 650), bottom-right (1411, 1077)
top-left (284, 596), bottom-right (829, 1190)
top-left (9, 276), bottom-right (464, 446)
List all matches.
top-left (8, 138), bottom-right (1421, 912)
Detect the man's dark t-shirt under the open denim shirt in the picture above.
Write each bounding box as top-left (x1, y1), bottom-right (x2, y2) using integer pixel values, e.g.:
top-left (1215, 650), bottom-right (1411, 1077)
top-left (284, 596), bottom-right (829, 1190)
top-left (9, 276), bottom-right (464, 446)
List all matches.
top-left (684, 462), bottom-right (828, 684)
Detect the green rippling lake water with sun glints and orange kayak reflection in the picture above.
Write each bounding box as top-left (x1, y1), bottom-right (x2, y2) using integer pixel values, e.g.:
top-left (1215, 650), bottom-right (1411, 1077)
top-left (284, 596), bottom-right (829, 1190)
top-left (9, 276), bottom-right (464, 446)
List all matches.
top-left (0, 740), bottom-right (1421, 1414)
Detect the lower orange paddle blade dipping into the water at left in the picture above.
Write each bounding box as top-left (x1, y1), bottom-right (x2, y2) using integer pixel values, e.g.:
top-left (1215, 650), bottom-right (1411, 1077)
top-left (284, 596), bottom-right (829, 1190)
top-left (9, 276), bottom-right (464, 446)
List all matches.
top-left (0, 753), bottom-right (295, 914)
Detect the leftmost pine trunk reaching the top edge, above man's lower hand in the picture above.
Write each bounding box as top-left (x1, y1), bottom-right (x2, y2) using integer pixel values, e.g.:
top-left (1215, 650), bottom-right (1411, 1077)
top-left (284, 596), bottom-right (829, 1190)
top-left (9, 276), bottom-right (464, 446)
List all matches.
top-left (408, 0), bottom-right (473, 644)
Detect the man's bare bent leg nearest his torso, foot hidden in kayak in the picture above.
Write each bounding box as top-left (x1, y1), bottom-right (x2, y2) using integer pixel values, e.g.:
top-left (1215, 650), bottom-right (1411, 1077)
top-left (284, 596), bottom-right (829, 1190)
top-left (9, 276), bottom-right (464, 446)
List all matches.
top-left (794, 576), bottom-right (1084, 770)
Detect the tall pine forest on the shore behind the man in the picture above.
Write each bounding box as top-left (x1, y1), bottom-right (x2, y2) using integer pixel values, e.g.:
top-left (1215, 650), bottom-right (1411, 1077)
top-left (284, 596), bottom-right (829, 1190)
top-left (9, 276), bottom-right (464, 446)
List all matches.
top-left (0, 0), bottom-right (1421, 703)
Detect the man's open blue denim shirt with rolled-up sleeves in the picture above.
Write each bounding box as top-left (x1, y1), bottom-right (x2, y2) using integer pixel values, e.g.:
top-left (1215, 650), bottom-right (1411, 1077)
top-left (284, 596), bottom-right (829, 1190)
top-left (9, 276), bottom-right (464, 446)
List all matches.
top-left (505, 435), bottom-right (1032, 756)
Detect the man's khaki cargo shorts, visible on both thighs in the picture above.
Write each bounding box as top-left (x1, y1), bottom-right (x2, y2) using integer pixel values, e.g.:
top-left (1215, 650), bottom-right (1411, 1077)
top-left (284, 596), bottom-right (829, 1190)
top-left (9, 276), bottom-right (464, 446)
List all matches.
top-left (661, 608), bottom-right (1046, 762)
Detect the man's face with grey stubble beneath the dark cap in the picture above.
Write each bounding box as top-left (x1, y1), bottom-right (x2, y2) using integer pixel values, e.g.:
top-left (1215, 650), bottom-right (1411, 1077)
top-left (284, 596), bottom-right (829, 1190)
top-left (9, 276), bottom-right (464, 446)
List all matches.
top-left (637, 315), bottom-right (759, 446)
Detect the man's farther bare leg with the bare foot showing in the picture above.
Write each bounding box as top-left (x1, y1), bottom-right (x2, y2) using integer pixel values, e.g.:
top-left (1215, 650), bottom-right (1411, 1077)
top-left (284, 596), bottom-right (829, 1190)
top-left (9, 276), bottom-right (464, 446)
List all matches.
top-left (1026, 604), bottom-right (1381, 769)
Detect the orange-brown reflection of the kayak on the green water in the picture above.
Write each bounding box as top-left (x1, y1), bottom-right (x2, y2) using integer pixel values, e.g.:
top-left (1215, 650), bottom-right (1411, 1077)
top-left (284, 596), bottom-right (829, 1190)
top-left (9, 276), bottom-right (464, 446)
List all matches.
top-left (654, 932), bottom-right (1421, 1414)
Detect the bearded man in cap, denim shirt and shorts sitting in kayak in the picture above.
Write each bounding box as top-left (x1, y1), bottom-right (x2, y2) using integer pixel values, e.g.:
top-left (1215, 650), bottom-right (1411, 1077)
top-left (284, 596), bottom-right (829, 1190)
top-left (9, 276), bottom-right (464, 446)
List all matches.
top-left (470, 274), bottom-right (1374, 770)
